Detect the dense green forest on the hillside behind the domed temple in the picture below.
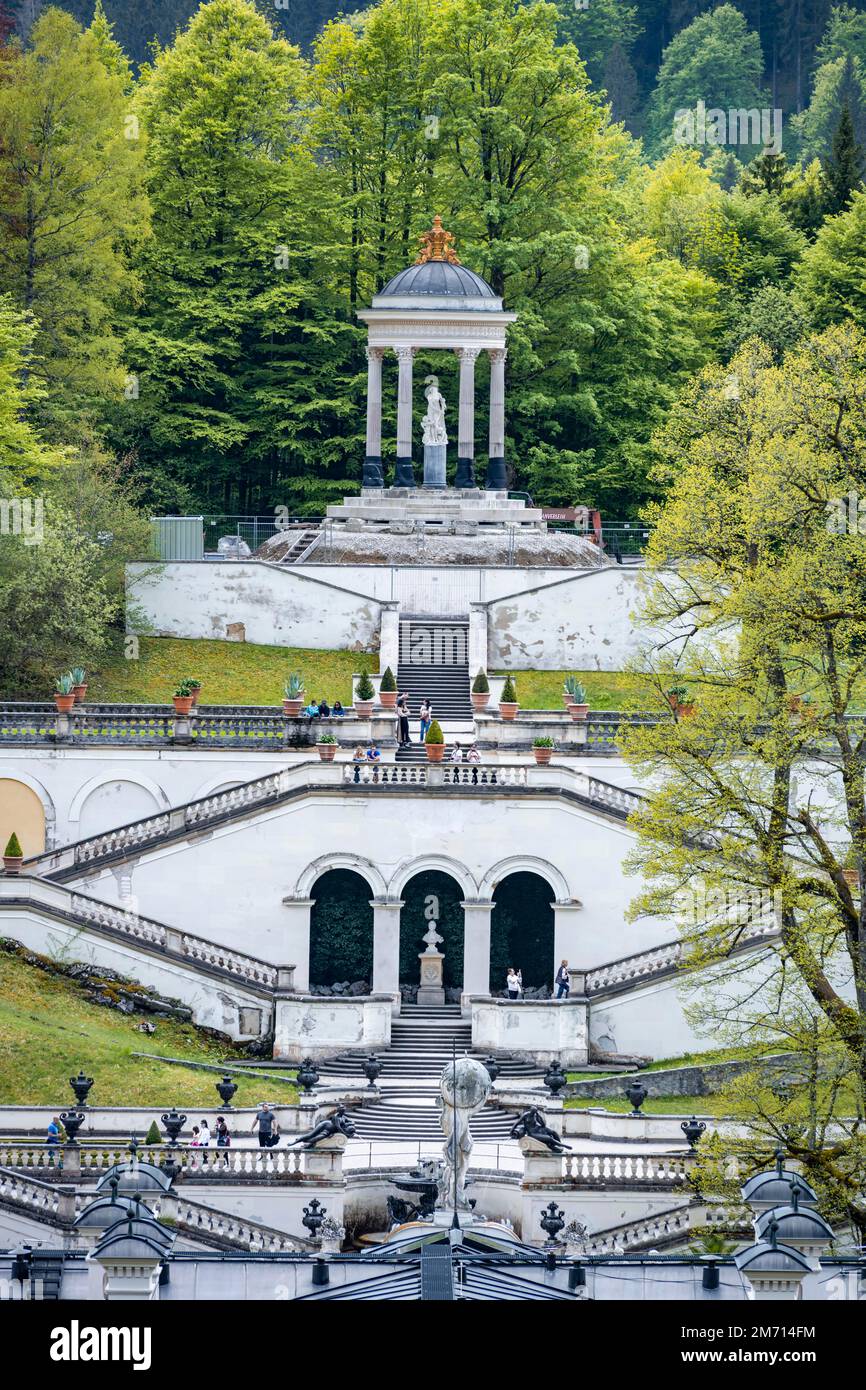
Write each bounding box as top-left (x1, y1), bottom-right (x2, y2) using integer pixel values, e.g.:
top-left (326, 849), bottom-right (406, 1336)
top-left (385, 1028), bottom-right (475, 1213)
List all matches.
top-left (0, 0), bottom-right (866, 542)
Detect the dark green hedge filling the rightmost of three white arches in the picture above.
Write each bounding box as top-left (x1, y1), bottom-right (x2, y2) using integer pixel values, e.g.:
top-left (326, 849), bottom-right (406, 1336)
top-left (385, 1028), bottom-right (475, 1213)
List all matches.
top-left (489, 873), bottom-right (556, 994)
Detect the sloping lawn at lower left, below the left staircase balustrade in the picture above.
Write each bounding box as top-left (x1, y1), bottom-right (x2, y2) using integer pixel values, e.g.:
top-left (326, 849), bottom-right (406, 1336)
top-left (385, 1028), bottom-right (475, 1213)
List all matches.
top-left (0, 951), bottom-right (296, 1118)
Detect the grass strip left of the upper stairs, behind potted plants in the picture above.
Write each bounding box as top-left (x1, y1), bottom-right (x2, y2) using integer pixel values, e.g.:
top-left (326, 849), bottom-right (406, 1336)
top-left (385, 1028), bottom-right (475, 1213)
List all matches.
top-left (88, 637), bottom-right (378, 705)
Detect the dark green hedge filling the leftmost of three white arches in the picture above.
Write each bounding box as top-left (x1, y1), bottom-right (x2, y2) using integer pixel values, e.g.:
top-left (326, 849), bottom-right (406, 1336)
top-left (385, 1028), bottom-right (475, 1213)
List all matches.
top-left (310, 869), bottom-right (373, 984)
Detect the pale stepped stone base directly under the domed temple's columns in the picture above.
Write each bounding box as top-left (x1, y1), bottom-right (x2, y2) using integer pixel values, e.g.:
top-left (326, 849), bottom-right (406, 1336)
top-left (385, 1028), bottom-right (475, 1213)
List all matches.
top-left (327, 488), bottom-right (546, 535)
